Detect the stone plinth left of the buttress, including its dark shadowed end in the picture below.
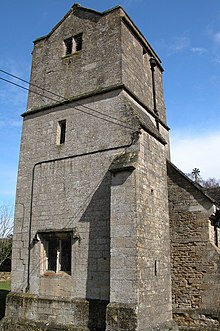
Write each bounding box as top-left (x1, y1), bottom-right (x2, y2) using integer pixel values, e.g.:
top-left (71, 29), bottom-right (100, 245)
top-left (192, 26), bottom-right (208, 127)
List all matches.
top-left (0, 292), bottom-right (108, 331)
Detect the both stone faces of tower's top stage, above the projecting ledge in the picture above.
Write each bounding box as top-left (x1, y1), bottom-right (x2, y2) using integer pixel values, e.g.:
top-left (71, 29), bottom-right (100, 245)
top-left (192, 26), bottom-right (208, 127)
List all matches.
top-left (27, 7), bottom-right (169, 161)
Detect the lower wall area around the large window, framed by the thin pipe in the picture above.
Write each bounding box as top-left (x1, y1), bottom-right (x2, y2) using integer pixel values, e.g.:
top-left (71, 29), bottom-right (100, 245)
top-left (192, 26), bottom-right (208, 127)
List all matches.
top-left (31, 153), bottom-right (111, 300)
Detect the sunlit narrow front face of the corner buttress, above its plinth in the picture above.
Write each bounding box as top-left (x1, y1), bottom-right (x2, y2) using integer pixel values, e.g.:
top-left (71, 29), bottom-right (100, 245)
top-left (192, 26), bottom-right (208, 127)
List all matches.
top-left (110, 169), bottom-right (137, 304)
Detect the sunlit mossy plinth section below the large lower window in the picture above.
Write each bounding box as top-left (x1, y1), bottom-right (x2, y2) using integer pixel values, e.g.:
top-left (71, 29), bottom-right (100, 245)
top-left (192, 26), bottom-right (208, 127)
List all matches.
top-left (3, 292), bottom-right (89, 331)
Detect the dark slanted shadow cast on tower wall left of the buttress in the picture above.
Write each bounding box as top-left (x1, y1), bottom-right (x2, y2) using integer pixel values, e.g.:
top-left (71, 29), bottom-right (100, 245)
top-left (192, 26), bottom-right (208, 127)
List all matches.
top-left (80, 172), bottom-right (111, 331)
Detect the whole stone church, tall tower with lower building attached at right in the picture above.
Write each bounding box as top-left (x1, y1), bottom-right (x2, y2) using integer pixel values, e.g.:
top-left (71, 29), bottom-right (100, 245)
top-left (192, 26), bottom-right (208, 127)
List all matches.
top-left (2, 5), bottom-right (220, 331)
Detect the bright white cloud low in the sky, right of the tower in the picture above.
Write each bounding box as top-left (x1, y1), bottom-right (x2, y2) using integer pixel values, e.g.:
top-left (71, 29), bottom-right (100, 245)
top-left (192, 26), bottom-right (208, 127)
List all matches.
top-left (171, 132), bottom-right (220, 179)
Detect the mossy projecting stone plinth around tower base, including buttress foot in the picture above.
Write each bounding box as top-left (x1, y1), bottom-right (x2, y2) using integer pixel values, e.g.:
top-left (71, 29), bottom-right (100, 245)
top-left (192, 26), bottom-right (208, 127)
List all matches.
top-left (0, 292), bottom-right (178, 331)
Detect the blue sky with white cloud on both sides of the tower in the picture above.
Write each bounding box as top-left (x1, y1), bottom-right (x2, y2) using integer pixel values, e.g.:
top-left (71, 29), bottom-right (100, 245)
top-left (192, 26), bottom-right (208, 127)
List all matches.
top-left (0, 0), bottom-right (220, 205)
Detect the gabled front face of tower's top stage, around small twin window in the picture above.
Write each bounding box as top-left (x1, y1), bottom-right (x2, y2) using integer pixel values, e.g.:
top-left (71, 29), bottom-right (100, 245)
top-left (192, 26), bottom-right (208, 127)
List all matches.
top-left (27, 7), bottom-right (121, 109)
